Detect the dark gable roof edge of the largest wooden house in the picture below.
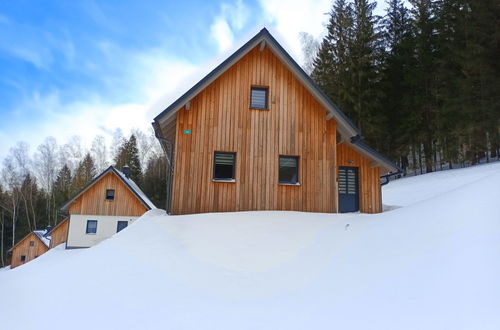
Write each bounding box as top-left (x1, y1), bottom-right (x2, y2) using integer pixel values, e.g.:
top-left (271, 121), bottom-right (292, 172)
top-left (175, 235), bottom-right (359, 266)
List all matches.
top-left (153, 28), bottom-right (400, 172)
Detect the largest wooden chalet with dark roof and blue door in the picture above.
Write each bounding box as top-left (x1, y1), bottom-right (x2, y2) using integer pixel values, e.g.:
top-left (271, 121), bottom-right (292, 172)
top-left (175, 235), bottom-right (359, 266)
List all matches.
top-left (153, 29), bottom-right (399, 214)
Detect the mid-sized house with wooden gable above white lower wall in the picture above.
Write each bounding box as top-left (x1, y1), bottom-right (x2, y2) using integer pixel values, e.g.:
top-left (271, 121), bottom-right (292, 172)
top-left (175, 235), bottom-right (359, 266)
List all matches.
top-left (58, 166), bottom-right (156, 249)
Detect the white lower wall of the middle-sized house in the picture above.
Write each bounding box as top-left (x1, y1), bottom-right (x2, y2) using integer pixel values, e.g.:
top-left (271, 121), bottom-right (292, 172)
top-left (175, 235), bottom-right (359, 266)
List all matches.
top-left (66, 214), bottom-right (138, 249)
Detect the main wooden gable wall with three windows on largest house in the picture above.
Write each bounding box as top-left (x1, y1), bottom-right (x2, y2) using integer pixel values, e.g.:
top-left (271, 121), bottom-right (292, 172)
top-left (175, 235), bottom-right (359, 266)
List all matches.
top-left (172, 47), bottom-right (338, 214)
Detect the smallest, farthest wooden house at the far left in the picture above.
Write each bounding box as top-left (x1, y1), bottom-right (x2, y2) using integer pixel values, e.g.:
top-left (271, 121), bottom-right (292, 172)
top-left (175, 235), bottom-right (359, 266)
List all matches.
top-left (10, 229), bottom-right (50, 268)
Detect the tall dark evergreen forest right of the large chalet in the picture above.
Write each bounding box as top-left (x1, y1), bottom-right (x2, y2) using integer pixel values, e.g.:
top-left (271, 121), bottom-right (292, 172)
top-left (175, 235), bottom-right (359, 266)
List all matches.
top-left (310, 0), bottom-right (500, 173)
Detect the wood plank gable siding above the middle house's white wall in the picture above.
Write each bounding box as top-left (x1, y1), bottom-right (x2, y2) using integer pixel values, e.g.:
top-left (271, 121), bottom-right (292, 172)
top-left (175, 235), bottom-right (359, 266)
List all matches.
top-left (69, 172), bottom-right (147, 217)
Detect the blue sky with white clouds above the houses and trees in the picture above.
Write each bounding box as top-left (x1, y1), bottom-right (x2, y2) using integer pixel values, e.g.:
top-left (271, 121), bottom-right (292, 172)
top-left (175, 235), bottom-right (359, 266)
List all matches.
top-left (0, 0), bottom-right (386, 159)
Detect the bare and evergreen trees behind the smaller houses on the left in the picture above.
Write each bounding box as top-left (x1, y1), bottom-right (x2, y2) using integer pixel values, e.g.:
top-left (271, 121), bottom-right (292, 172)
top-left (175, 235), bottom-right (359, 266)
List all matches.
top-left (0, 129), bottom-right (166, 266)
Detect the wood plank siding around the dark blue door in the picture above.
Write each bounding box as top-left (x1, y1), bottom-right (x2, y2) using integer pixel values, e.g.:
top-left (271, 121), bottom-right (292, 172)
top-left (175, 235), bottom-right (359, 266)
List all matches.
top-left (337, 143), bottom-right (382, 213)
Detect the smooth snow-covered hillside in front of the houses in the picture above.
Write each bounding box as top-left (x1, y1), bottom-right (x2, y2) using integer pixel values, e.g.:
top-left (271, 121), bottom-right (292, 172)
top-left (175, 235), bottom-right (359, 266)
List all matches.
top-left (0, 164), bottom-right (500, 330)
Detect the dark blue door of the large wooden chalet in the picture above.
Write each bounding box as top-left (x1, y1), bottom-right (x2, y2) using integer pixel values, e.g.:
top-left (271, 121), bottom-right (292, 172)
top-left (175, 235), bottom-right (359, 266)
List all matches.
top-left (339, 166), bottom-right (359, 213)
